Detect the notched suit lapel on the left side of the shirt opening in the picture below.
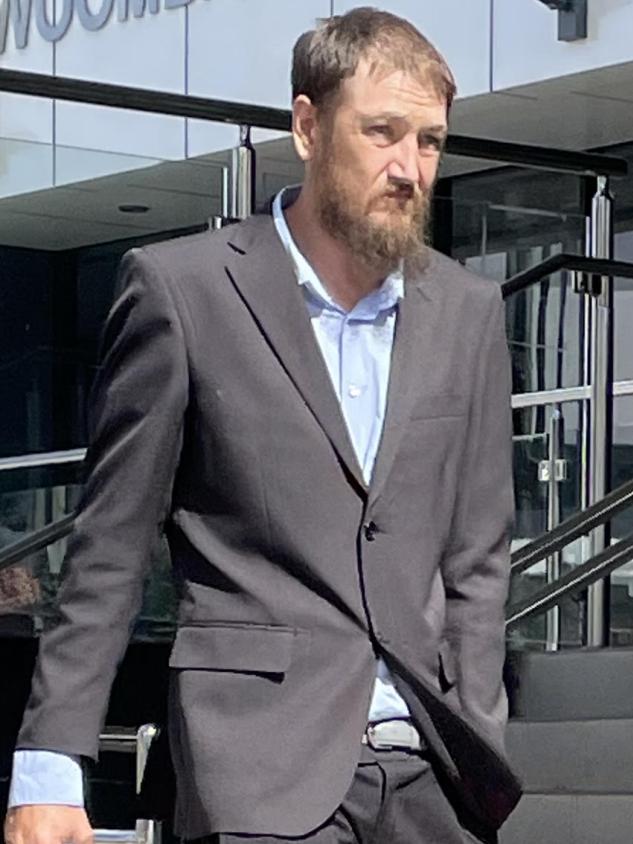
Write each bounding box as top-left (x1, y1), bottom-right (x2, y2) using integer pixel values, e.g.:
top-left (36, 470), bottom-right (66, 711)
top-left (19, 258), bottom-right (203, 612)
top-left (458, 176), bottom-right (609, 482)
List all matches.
top-left (226, 214), bottom-right (367, 494)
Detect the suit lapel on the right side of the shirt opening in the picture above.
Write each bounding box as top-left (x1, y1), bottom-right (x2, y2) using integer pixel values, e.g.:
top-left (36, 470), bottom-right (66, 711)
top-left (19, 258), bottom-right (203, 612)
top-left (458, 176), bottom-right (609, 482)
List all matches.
top-left (367, 269), bottom-right (436, 508)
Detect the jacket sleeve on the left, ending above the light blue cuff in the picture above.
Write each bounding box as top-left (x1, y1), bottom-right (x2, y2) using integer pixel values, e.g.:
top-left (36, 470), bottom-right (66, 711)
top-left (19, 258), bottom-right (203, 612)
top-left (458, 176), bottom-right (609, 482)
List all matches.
top-left (17, 250), bottom-right (188, 758)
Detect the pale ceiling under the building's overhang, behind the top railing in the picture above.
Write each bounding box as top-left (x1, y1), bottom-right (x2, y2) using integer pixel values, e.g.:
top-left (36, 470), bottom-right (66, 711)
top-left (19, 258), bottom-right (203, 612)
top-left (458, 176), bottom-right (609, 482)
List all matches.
top-left (0, 63), bottom-right (633, 250)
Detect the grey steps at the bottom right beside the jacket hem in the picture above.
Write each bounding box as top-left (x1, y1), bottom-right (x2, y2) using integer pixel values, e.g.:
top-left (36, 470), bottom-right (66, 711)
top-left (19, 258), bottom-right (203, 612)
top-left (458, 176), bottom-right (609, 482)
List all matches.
top-left (499, 648), bottom-right (633, 844)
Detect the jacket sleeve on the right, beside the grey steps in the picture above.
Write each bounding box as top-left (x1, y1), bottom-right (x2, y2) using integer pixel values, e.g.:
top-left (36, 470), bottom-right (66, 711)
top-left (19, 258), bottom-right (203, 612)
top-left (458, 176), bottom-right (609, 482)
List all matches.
top-left (442, 295), bottom-right (514, 750)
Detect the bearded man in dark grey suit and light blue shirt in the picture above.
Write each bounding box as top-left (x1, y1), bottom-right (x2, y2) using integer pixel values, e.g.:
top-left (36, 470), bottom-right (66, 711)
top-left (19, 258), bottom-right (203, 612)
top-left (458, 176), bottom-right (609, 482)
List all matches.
top-left (7, 9), bottom-right (519, 844)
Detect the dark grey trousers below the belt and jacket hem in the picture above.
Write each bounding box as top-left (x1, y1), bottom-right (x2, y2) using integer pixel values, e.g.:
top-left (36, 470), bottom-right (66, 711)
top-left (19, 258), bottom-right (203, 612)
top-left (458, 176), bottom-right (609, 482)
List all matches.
top-left (205, 748), bottom-right (488, 844)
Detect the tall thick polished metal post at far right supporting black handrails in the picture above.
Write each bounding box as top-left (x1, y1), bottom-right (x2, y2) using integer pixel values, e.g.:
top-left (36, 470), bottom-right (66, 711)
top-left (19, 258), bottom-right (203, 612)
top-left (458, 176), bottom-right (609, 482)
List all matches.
top-left (587, 176), bottom-right (613, 647)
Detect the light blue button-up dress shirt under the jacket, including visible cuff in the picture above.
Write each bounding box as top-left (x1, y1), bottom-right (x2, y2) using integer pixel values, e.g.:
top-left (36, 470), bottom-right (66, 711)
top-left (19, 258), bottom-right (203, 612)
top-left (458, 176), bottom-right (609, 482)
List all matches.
top-left (9, 191), bottom-right (409, 806)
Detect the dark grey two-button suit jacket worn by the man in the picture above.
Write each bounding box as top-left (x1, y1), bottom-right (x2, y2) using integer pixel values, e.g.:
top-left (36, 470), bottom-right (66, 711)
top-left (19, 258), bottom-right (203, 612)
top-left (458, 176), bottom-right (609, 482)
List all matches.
top-left (18, 209), bottom-right (519, 838)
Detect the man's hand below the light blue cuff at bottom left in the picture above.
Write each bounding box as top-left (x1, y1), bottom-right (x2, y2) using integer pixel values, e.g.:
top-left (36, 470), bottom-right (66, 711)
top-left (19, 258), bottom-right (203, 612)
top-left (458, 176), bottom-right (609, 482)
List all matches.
top-left (4, 804), bottom-right (92, 844)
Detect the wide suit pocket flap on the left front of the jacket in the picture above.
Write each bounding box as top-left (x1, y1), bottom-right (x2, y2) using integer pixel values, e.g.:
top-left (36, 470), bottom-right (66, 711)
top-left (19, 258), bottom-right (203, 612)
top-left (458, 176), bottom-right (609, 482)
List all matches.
top-left (169, 624), bottom-right (305, 674)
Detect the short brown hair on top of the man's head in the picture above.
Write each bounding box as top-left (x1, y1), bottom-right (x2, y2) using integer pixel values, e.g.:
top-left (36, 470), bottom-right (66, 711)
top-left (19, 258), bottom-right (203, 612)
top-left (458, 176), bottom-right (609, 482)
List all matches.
top-left (292, 6), bottom-right (456, 110)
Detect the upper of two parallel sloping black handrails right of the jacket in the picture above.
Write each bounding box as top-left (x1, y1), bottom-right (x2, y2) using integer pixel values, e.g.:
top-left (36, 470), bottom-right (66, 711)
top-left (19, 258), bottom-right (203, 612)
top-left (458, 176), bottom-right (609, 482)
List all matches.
top-left (510, 474), bottom-right (633, 574)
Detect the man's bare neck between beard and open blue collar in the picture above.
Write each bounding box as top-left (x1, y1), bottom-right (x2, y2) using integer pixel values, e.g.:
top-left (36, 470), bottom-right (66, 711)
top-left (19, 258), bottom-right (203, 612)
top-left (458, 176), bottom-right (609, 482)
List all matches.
top-left (284, 188), bottom-right (388, 311)
